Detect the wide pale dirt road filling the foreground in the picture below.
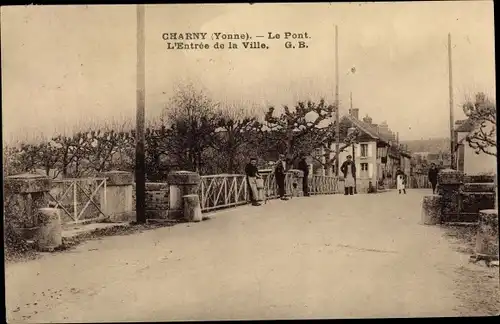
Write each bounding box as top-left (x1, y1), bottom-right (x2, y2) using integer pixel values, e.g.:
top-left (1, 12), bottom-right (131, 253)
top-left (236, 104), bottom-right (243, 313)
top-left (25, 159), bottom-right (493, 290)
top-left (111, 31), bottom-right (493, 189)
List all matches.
top-left (6, 190), bottom-right (467, 323)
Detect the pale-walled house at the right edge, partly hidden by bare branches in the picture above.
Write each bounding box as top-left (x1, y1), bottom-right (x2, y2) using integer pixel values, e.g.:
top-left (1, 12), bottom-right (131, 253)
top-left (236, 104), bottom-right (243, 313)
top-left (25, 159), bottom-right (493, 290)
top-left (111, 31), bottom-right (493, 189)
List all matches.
top-left (454, 119), bottom-right (497, 175)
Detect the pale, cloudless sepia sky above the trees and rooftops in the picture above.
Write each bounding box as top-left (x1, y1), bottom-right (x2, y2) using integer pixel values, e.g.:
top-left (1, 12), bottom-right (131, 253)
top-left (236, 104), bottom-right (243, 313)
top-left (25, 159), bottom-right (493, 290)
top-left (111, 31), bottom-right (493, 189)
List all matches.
top-left (1, 1), bottom-right (495, 141)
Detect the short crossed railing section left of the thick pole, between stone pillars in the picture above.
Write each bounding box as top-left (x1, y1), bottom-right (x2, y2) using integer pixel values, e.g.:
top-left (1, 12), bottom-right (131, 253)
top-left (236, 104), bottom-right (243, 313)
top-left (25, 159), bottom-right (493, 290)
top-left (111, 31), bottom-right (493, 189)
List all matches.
top-left (48, 178), bottom-right (107, 224)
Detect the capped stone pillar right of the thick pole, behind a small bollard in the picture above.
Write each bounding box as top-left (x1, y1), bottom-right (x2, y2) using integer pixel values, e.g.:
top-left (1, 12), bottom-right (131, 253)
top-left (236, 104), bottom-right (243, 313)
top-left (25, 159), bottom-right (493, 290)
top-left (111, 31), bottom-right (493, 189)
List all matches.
top-left (167, 171), bottom-right (201, 219)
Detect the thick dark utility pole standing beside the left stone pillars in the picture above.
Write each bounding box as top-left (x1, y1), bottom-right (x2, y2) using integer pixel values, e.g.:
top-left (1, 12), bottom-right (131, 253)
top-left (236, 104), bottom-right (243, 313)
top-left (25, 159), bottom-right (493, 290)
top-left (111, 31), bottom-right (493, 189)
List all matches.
top-left (135, 4), bottom-right (146, 224)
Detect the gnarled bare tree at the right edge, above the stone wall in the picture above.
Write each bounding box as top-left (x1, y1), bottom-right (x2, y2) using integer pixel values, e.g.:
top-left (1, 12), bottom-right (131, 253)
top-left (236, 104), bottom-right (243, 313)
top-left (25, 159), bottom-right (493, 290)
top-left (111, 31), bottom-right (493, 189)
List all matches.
top-left (463, 92), bottom-right (497, 156)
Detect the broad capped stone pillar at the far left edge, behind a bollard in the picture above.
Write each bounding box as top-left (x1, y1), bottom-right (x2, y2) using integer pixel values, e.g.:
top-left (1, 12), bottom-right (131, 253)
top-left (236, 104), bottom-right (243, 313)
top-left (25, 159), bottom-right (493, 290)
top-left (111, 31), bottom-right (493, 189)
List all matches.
top-left (4, 174), bottom-right (51, 240)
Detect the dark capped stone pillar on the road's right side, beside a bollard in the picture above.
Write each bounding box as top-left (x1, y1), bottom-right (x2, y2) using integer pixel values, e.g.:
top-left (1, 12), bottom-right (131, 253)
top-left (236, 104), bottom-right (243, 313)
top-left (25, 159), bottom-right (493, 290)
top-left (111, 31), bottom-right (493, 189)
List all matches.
top-left (438, 169), bottom-right (464, 222)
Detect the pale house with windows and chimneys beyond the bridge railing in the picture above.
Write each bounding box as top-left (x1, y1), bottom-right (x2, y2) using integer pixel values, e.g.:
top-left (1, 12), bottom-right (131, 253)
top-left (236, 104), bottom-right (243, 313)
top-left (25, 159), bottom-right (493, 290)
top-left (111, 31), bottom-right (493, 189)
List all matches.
top-left (316, 108), bottom-right (411, 193)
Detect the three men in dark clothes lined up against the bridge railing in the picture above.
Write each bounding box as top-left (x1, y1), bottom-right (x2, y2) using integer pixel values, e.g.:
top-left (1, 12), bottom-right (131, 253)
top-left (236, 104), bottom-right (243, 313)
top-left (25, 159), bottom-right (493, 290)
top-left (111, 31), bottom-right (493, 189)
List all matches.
top-left (245, 154), bottom-right (309, 206)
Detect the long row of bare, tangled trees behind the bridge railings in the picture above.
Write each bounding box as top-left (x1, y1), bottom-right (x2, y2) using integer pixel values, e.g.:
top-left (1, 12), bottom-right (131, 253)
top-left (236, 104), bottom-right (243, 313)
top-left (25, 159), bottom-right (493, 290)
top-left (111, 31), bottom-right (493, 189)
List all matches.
top-left (4, 86), bottom-right (356, 180)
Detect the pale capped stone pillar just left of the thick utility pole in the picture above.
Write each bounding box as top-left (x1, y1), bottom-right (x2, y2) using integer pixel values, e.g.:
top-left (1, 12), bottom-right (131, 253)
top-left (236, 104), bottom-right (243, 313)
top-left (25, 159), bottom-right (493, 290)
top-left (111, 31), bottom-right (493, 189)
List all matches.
top-left (100, 171), bottom-right (135, 222)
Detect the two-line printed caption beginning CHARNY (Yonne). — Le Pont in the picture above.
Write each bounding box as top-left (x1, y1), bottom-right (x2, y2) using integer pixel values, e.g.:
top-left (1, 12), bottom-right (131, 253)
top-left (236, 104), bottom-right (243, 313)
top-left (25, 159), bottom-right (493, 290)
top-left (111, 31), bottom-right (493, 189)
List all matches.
top-left (161, 32), bottom-right (311, 50)
